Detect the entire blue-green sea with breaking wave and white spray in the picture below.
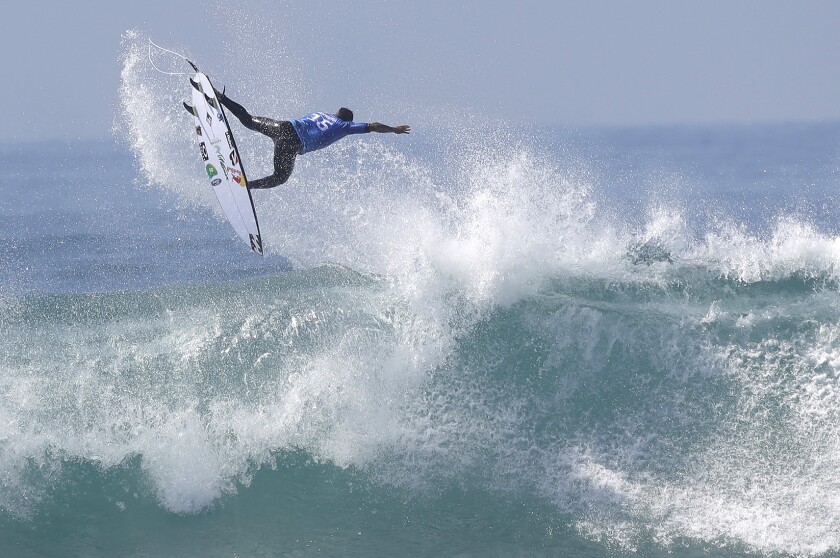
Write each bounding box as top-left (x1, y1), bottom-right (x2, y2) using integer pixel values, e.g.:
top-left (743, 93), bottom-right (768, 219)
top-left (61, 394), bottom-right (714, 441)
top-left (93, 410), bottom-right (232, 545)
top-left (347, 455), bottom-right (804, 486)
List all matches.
top-left (0, 38), bottom-right (840, 558)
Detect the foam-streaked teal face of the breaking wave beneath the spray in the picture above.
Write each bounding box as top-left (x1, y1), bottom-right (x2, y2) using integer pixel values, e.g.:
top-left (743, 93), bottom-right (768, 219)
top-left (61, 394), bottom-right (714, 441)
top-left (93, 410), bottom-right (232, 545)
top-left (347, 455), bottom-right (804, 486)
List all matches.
top-left (0, 256), bottom-right (840, 555)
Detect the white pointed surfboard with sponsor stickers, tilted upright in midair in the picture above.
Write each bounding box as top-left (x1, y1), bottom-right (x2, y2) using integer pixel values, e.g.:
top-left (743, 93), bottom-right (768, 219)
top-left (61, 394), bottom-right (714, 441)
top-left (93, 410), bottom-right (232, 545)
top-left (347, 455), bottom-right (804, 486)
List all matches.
top-left (185, 72), bottom-right (263, 255)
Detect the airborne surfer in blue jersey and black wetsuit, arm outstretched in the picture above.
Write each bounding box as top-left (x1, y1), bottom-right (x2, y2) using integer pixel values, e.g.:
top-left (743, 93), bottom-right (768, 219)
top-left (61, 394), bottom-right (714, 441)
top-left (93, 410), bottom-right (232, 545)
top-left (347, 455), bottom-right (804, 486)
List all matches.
top-left (214, 88), bottom-right (411, 189)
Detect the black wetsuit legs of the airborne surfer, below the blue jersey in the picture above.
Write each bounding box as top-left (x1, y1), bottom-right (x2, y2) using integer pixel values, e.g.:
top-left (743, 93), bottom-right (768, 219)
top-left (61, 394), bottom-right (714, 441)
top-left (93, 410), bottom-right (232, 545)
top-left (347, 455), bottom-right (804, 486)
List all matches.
top-left (216, 91), bottom-right (302, 189)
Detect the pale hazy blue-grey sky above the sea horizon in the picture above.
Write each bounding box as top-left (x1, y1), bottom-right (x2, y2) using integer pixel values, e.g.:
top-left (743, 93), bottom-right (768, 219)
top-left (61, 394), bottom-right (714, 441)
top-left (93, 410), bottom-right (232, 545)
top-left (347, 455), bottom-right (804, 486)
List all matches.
top-left (0, 0), bottom-right (840, 142)
